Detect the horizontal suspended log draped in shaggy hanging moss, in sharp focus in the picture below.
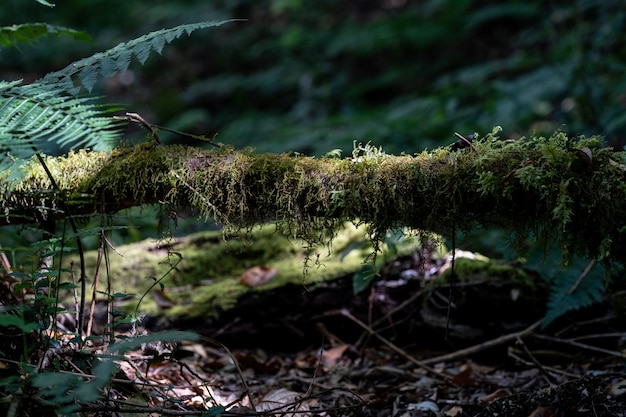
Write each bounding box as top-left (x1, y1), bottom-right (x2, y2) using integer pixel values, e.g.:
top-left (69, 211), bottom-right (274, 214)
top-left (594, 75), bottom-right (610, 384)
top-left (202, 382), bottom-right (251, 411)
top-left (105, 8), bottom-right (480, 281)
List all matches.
top-left (0, 131), bottom-right (626, 262)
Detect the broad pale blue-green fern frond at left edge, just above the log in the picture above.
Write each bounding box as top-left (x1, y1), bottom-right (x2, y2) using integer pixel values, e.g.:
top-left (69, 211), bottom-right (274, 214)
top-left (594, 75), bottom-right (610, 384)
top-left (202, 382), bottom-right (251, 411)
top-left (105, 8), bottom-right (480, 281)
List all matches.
top-left (0, 81), bottom-right (121, 169)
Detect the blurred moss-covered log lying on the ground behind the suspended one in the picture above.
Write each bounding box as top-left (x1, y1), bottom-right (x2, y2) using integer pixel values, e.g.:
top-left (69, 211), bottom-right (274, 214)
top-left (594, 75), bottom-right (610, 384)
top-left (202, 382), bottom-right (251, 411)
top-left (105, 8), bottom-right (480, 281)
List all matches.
top-left (78, 223), bottom-right (422, 324)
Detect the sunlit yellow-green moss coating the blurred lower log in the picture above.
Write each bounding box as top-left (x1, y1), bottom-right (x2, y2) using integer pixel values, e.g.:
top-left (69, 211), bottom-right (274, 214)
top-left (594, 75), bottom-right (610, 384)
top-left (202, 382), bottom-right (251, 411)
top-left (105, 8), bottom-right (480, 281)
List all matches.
top-left (74, 224), bottom-right (415, 319)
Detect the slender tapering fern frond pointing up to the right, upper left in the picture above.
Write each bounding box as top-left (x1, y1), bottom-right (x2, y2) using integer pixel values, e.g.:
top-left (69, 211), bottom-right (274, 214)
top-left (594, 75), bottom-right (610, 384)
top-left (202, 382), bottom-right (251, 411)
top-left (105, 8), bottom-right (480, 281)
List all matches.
top-left (42, 20), bottom-right (235, 94)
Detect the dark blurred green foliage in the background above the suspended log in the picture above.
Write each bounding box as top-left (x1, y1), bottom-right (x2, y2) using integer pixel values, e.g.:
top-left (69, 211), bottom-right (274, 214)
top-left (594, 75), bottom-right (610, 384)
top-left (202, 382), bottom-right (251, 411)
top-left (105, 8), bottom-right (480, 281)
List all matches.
top-left (0, 0), bottom-right (626, 155)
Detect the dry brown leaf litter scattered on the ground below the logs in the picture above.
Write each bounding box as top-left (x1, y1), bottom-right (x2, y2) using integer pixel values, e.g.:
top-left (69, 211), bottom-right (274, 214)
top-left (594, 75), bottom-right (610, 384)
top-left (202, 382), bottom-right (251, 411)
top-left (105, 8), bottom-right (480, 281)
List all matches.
top-left (98, 245), bottom-right (626, 417)
